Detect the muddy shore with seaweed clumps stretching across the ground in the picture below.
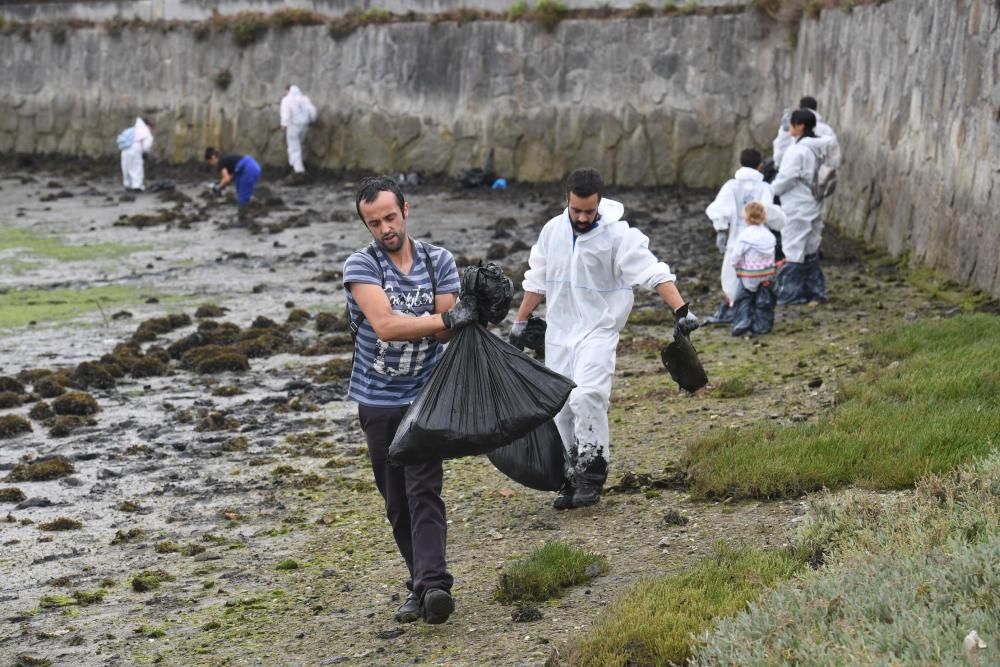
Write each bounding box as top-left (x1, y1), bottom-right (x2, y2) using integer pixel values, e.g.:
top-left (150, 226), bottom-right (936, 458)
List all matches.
top-left (0, 163), bottom-right (972, 666)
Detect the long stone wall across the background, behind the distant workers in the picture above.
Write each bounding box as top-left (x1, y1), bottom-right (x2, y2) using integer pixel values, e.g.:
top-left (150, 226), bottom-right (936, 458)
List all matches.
top-left (0, 12), bottom-right (790, 186)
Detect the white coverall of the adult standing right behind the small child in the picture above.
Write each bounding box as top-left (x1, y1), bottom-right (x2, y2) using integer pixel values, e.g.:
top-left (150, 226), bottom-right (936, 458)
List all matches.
top-left (705, 167), bottom-right (785, 305)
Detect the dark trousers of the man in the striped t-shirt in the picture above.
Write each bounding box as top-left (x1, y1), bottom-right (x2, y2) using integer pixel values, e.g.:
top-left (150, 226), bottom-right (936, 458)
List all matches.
top-left (358, 405), bottom-right (454, 599)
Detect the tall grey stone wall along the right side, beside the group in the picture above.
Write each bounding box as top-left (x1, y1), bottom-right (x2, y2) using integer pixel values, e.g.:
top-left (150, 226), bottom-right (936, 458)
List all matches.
top-left (790, 0), bottom-right (1000, 297)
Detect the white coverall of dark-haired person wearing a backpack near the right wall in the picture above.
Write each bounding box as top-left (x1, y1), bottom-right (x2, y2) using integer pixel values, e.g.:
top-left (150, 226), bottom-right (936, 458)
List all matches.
top-left (771, 137), bottom-right (832, 264)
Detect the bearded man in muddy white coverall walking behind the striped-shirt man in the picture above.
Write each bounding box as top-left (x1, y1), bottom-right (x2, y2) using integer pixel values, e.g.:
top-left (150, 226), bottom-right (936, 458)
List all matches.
top-left (510, 169), bottom-right (699, 509)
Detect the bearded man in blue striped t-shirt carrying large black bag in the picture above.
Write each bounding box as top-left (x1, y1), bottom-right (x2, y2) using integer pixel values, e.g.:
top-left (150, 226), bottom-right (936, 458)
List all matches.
top-left (344, 177), bottom-right (478, 623)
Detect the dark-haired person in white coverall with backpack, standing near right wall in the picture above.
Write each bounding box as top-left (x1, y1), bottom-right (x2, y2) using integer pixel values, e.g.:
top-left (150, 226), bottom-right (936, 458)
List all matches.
top-left (771, 109), bottom-right (833, 305)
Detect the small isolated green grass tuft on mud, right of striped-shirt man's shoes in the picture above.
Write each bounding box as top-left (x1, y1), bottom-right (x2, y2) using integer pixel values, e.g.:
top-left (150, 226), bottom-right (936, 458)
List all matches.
top-left (496, 542), bottom-right (608, 604)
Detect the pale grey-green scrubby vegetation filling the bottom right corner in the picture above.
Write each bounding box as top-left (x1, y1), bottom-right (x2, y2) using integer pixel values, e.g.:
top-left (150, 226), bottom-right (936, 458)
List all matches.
top-left (695, 451), bottom-right (1000, 665)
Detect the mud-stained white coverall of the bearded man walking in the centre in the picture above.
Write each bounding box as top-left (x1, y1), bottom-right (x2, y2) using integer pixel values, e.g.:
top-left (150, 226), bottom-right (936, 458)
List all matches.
top-left (523, 199), bottom-right (674, 475)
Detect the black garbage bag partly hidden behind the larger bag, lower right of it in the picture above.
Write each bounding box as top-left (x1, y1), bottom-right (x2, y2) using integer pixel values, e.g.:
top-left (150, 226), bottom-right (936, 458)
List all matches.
top-left (486, 420), bottom-right (566, 491)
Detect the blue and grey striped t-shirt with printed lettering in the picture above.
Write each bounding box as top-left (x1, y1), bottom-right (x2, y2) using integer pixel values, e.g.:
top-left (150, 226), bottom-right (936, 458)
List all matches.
top-left (344, 239), bottom-right (459, 407)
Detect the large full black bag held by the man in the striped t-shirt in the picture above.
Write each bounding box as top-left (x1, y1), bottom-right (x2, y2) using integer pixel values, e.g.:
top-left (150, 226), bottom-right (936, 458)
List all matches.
top-left (389, 324), bottom-right (576, 465)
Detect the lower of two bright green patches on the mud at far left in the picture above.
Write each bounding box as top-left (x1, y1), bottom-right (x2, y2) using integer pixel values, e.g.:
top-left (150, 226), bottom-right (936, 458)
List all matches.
top-left (0, 285), bottom-right (150, 329)
